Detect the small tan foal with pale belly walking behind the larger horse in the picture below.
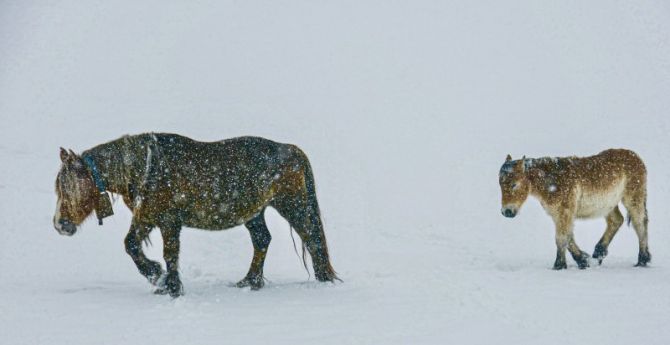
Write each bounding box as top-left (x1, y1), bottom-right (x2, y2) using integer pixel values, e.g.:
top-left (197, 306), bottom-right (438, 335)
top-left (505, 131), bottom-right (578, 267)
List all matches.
top-left (499, 150), bottom-right (651, 270)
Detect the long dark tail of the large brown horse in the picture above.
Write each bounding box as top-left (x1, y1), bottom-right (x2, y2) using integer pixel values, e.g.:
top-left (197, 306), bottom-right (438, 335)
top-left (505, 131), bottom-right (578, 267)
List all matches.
top-left (299, 151), bottom-right (342, 281)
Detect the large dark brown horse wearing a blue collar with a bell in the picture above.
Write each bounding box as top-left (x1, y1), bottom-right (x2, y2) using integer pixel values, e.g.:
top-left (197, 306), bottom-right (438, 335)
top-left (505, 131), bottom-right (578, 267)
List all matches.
top-left (53, 133), bottom-right (338, 297)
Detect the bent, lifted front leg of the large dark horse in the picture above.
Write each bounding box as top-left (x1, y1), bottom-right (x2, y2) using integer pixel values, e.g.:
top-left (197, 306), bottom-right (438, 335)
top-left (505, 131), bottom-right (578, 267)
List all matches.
top-left (124, 220), bottom-right (163, 285)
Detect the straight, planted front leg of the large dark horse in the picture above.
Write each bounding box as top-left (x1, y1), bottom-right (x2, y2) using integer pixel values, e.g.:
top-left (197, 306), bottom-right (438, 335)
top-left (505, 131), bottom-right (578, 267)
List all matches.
top-left (156, 226), bottom-right (184, 297)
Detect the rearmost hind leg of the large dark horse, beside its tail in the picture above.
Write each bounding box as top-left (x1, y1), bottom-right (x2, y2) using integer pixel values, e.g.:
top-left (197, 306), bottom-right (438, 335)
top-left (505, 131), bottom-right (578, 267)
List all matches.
top-left (272, 195), bottom-right (339, 282)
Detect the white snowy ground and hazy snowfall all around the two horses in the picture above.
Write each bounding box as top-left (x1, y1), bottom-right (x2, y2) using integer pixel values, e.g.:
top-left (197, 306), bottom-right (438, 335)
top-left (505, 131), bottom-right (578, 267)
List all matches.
top-left (0, 0), bottom-right (670, 345)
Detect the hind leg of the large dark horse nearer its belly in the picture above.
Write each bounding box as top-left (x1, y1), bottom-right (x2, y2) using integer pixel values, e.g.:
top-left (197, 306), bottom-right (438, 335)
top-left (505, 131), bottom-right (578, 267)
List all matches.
top-left (236, 211), bottom-right (272, 290)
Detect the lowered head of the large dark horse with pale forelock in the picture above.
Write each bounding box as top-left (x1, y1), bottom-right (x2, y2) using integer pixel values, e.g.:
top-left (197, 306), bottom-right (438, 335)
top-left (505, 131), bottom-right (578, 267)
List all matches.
top-left (53, 148), bottom-right (97, 236)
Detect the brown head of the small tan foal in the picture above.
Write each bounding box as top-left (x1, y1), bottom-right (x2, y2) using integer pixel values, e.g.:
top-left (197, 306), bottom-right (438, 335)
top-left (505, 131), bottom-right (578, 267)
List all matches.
top-left (499, 155), bottom-right (530, 218)
